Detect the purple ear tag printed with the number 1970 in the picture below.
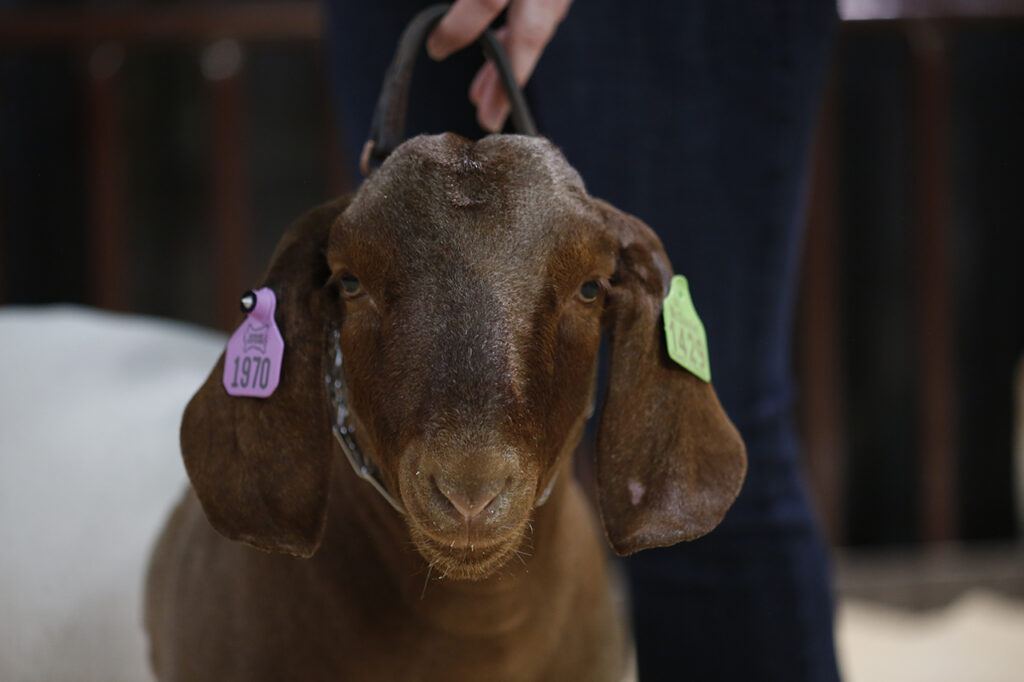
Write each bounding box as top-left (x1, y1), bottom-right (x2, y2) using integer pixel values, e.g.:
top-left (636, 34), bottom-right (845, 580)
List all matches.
top-left (223, 287), bottom-right (285, 397)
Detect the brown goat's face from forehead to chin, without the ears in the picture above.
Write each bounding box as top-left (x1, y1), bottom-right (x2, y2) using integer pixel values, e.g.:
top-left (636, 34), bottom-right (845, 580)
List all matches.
top-left (328, 134), bottom-right (617, 578)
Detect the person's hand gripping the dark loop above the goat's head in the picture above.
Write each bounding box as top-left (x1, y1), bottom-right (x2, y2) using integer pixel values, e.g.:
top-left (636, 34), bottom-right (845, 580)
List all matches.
top-left (427, 0), bottom-right (571, 132)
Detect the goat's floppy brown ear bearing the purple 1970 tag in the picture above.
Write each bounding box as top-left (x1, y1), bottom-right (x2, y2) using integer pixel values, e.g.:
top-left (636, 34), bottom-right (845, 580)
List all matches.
top-left (181, 199), bottom-right (347, 556)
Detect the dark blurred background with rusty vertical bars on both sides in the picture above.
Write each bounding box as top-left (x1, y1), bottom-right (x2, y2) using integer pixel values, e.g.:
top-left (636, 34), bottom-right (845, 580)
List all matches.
top-left (0, 0), bottom-right (1024, 675)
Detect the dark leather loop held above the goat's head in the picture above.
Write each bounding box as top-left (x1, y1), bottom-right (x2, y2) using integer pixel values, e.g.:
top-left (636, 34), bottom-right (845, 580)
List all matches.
top-left (359, 4), bottom-right (537, 175)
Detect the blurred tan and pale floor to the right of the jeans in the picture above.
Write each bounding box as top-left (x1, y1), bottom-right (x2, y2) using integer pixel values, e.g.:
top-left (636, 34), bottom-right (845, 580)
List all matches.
top-left (836, 543), bottom-right (1024, 682)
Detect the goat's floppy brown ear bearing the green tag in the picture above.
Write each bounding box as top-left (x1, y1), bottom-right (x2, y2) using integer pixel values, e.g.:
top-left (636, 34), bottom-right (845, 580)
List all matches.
top-left (597, 202), bottom-right (746, 555)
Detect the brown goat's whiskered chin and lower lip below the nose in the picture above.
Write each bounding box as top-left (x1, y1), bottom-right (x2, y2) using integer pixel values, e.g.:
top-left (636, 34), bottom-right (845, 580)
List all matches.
top-left (410, 518), bottom-right (531, 581)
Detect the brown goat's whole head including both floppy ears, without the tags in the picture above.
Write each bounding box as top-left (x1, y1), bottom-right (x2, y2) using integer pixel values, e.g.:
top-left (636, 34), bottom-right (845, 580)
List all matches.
top-left (181, 135), bottom-right (745, 579)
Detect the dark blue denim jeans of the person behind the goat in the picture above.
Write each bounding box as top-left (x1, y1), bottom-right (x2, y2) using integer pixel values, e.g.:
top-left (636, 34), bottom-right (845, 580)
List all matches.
top-left (328, 0), bottom-right (839, 682)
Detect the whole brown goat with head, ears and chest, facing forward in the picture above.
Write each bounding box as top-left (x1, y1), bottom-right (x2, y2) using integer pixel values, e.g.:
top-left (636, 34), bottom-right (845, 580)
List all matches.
top-left (145, 134), bottom-right (745, 682)
